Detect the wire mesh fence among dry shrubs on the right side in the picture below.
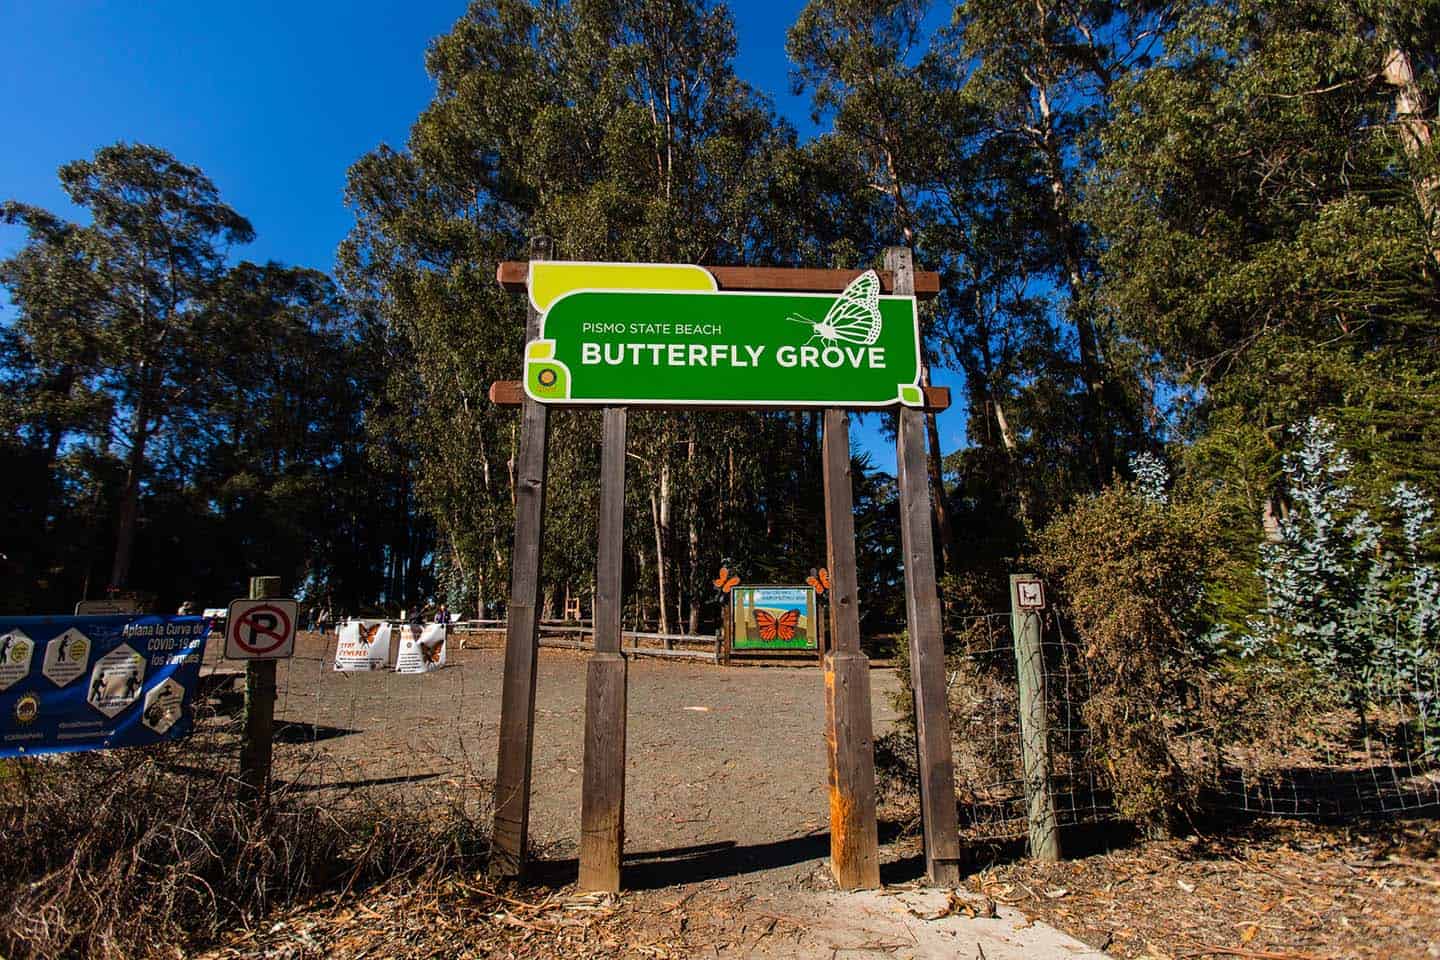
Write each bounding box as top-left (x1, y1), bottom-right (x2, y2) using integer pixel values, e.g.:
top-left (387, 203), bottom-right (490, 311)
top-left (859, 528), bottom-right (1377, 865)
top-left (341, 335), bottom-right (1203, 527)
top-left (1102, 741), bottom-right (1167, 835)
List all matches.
top-left (948, 610), bottom-right (1440, 841)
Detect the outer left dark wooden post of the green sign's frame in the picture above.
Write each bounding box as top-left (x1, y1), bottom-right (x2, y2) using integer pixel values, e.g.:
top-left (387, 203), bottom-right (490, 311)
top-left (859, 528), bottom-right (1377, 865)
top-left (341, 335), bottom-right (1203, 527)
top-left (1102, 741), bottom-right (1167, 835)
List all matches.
top-left (490, 237), bottom-right (550, 877)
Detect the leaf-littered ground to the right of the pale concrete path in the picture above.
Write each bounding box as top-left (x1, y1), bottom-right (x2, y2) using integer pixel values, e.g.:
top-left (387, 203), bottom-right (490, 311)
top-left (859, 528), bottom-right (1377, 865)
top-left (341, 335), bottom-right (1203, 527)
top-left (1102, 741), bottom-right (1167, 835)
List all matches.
top-left (968, 819), bottom-right (1440, 960)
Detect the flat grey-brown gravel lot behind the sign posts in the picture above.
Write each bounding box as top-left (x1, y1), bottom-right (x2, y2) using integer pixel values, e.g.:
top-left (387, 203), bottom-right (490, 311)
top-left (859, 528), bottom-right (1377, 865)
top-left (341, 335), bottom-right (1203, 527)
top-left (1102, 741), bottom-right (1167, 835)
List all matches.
top-left (207, 635), bottom-right (897, 887)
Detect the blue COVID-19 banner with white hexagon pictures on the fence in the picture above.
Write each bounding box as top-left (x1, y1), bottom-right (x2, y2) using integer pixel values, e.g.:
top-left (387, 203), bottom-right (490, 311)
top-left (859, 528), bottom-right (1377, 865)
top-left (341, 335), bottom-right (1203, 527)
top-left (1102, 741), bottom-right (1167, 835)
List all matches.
top-left (0, 613), bottom-right (210, 757)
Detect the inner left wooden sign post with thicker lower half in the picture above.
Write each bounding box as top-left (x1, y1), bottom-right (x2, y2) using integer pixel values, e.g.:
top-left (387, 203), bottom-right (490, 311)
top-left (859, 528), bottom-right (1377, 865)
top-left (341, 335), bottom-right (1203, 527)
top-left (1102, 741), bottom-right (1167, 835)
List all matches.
top-left (579, 407), bottom-right (626, 892)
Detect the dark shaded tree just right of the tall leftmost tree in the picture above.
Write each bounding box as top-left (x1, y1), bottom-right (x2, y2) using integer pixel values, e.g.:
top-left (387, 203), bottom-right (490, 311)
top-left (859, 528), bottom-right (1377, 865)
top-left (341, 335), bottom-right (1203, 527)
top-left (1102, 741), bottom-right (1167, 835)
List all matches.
top-left (195, 262), bottom-right (400, 610)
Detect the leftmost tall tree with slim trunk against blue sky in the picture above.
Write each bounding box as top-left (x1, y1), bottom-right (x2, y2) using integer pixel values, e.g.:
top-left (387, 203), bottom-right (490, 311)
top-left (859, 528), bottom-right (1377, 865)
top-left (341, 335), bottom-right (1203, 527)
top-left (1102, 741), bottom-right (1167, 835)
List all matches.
top-left (0, 142), bottom-right (253, 586)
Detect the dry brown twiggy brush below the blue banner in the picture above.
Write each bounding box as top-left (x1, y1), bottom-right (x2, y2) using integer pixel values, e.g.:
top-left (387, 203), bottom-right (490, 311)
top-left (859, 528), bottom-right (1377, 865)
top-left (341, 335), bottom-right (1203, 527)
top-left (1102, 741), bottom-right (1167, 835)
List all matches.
top-left (0, 741), bottom-right (484, 960)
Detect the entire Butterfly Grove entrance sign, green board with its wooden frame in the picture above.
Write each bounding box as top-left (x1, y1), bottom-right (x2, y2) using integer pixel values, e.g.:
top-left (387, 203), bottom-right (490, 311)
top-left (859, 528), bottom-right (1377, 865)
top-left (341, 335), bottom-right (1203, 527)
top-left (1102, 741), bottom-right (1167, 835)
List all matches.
top-left (490, 246), bottom-right (959, 891)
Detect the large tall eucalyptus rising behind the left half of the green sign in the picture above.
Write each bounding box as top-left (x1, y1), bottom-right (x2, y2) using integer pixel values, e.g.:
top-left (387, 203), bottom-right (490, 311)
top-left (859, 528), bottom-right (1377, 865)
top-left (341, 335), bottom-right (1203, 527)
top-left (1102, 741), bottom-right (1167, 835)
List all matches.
top-left (341, 0), bottom-right (829, 626)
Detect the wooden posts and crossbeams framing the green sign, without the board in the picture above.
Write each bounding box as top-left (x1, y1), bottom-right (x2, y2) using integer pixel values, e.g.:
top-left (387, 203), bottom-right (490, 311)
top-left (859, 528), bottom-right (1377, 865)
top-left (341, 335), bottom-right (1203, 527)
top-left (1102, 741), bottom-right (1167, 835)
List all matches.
top-left (490, 246), bottom-right (960, 891)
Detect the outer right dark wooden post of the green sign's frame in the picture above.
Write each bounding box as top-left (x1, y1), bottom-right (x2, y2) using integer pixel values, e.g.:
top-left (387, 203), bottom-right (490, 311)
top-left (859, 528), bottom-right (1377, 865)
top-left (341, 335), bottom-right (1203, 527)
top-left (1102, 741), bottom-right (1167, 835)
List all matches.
top-left (886, 246), bottom-right (960, 887)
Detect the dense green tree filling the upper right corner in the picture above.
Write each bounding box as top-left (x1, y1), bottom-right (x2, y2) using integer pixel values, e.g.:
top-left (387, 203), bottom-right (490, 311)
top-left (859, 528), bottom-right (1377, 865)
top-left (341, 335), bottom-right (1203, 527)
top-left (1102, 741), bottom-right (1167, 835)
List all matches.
top-left (1090, 0), bottom-right (1440, 541)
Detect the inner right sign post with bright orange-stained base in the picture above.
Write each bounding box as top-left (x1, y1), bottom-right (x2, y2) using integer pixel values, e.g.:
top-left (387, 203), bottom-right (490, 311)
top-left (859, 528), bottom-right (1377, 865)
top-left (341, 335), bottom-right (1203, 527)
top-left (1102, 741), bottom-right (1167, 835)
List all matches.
top-left (822, 409), bottom-right (880, 889)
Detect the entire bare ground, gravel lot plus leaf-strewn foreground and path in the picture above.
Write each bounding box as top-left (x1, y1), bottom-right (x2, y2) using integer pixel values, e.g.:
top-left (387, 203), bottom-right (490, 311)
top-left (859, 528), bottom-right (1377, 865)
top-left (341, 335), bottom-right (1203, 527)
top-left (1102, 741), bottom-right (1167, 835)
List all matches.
top-left (194, 638), bottom-right (1440, 960)
